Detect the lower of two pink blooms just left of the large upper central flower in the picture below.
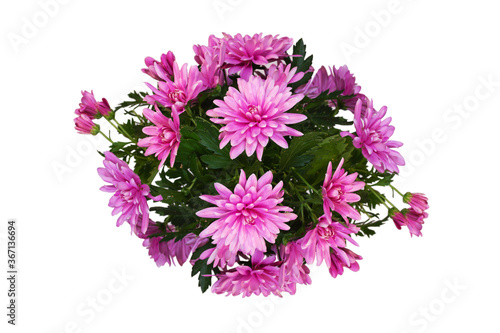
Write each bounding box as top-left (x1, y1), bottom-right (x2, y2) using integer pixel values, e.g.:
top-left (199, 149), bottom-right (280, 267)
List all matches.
top-left (137, 108), bottom-right (181, 170)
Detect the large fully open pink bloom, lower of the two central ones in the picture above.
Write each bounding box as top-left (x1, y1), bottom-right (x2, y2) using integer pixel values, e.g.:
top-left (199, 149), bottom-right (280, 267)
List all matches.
top-left (196, 170), bottom-right (297, 255)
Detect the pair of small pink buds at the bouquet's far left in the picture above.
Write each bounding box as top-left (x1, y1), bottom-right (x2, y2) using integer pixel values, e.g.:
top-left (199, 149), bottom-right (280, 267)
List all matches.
top-left (74, 91), bottom-right (111, 135)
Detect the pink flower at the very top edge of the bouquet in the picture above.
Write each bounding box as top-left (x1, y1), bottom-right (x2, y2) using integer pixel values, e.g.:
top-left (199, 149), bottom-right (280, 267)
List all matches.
top-left (223, 33), bottom-right (293, 80)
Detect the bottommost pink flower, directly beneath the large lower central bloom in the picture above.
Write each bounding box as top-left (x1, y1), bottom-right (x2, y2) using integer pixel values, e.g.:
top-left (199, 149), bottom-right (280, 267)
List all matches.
top-left (212, 251), bottom-right (281, 297)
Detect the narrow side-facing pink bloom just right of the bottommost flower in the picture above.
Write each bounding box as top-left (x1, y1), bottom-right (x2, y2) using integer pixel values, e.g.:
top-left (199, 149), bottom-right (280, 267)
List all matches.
top-left (279, 241), bottom-right (311, 295)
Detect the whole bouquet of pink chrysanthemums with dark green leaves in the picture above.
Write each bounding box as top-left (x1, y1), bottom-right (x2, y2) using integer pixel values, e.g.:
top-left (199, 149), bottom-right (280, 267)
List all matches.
top-left (75, 34), bottom-right (429, 297)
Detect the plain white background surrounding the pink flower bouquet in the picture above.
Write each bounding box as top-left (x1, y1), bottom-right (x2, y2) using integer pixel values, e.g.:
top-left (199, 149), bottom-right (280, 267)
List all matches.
top-left (0, 0), bottom-right (500, 333)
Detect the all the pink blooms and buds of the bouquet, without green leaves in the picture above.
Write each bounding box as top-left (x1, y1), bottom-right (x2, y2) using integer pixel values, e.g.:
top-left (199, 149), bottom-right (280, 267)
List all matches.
top-left (75, 34), bottom-right (429, 297)
